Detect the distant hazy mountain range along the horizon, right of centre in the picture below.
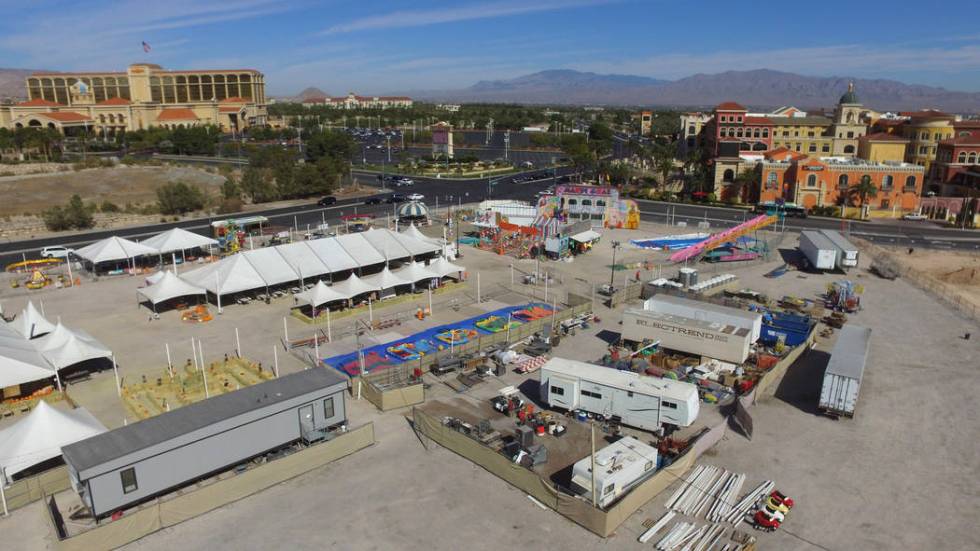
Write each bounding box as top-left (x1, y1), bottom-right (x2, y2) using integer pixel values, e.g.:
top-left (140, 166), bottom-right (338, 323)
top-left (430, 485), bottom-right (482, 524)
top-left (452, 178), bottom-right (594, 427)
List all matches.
top-left (410, 69), bottom-right (980, 113)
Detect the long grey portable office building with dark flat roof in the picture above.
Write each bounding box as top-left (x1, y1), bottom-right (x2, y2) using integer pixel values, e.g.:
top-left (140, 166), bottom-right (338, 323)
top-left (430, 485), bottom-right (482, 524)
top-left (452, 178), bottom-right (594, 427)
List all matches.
top-left (62, 368), bottom-right (347, 518)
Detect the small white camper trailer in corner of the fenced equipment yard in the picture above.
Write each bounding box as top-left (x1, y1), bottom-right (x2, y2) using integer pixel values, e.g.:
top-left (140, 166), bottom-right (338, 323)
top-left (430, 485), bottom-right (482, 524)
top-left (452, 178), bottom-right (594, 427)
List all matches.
top-left (572, 436), bottom-right (657, 507)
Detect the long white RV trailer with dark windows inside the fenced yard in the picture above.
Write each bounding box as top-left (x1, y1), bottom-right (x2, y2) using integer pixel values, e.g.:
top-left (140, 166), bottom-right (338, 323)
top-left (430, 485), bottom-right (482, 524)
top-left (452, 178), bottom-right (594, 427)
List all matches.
top-left (539, 358), bottom-right (700, 431)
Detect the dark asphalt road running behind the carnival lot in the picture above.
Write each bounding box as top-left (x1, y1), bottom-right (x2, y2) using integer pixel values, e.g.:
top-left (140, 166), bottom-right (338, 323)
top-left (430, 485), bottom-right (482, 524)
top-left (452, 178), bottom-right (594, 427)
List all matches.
top-left (0, 168), bottom-right (980, 265)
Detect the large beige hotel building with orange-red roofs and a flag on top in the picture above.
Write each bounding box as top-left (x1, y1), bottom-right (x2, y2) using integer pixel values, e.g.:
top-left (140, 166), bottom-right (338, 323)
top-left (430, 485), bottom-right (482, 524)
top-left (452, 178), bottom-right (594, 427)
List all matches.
top-left (0, 63), bottom-right (266, 136)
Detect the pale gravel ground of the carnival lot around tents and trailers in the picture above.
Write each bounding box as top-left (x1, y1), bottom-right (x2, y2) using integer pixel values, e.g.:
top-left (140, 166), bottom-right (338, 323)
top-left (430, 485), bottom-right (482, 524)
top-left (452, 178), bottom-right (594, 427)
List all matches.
top-left (0, 221), bottom-right (980, 551)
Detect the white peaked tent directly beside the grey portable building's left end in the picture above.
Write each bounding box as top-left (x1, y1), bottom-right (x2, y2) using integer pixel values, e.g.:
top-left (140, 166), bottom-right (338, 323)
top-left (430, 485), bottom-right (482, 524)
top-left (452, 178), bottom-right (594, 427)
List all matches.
top-left (0, 400), bottom-right (108, 484)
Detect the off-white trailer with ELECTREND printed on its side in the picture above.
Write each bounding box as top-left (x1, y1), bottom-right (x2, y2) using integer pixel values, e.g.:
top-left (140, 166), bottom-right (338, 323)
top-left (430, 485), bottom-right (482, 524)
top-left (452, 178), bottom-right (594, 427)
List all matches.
top-left (621, 308), bottom-right (752, 364)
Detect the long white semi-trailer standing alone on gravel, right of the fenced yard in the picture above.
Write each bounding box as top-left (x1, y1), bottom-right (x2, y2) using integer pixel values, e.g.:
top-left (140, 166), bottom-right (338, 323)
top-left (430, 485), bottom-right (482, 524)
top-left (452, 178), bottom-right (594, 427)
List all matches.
top-left (819, 324), bottom-right (871, 417)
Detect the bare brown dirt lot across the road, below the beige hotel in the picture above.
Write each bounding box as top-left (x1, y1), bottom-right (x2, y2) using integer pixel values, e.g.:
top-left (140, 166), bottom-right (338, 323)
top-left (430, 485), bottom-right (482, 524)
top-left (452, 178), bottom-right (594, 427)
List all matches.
top-left (0, 166), bottom-right (224, 216)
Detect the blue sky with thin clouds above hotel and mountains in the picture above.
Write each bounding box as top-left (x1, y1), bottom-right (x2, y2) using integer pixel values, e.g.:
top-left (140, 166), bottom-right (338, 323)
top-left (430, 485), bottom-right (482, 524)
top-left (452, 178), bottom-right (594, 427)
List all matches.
top-left (0, 0), bottom-right (980, 95)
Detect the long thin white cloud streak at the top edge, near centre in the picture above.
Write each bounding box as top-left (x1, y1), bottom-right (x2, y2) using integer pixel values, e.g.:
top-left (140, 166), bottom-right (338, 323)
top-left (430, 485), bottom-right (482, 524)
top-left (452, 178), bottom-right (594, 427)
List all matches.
top-left (323, 0), bottom-right (609, 34)
